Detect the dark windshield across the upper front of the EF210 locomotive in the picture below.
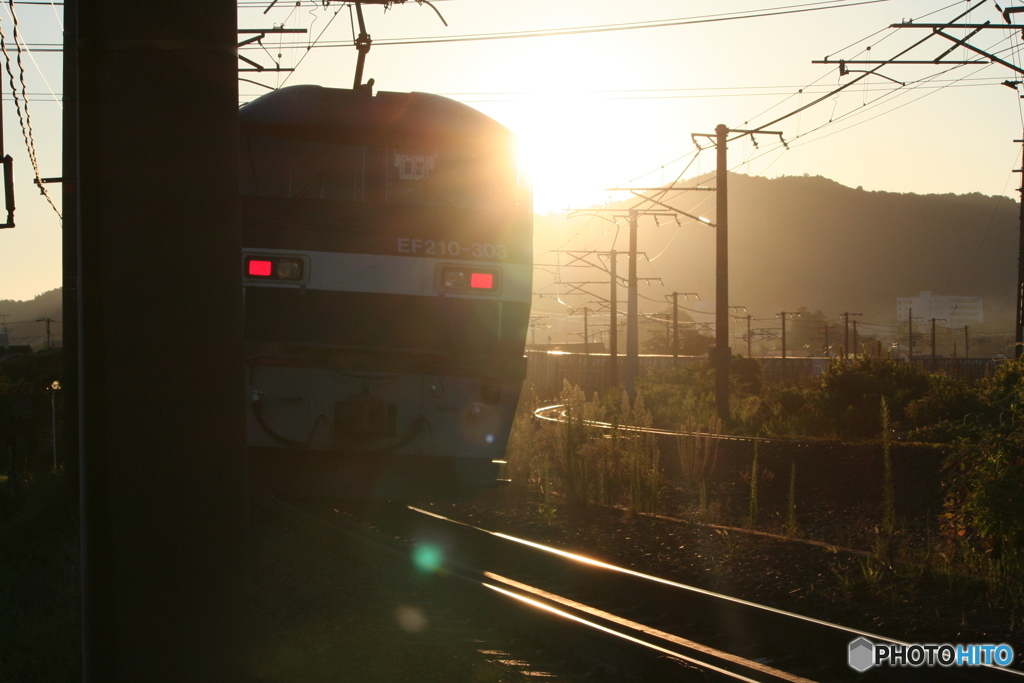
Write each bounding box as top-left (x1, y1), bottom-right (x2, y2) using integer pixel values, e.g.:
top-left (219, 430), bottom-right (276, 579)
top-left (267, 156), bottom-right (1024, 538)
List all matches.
top-left (242, 135), bottom-right (518, 209)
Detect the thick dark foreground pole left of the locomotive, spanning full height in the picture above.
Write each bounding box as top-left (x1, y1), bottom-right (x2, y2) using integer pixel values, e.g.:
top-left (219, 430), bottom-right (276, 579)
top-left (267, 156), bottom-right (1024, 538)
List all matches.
top-left (75, 0), bottom-right (247, 683)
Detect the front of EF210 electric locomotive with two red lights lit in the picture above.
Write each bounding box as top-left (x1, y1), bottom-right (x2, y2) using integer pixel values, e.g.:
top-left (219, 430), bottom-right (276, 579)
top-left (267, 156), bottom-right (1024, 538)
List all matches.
top-left (240, 86), bottom-right (532, 500)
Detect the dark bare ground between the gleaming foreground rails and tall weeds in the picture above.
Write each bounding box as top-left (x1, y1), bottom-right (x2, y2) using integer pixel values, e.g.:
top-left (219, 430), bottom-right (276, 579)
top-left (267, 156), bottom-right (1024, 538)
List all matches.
top-left (421, 473), bottom-right (1024, 667)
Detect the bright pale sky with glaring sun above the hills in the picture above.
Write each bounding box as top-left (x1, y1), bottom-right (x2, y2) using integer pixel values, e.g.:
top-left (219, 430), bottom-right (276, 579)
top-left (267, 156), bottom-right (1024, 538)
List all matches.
top-left (0, 0), bottom-right (1024, 300)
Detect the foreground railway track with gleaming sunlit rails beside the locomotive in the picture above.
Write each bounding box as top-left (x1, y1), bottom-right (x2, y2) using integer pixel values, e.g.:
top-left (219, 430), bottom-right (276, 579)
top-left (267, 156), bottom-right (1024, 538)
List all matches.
top-left (268, 497), bottom-right (1024, 682)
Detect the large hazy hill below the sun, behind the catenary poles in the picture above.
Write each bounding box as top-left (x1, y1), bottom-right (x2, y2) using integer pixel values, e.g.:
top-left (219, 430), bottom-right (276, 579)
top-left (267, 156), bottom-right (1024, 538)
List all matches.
top-left (536, 174), bottom-right (1019, 342)
